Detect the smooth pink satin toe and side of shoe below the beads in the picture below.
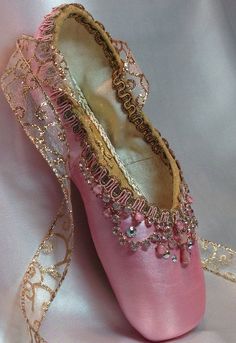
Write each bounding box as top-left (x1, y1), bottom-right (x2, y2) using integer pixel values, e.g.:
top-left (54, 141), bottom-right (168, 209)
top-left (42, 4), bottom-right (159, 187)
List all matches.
top-left (69, 161), bottom-right (205, 341)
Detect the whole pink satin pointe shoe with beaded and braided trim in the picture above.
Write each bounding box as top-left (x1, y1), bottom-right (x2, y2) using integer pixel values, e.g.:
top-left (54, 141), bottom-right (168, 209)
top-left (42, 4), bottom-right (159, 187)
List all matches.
top-left (1, 4), bottom-right (205, 341)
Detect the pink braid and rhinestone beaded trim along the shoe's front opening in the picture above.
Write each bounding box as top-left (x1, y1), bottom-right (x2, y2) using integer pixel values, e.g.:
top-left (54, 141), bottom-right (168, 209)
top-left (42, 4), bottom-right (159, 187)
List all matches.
top-left (64, 104), bottom-right (197, 265)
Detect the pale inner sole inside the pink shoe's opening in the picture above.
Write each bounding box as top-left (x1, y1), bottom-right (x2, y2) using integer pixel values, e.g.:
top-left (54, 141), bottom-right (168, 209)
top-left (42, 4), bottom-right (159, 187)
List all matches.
top-left (58, 18), bottom-right (173, 209)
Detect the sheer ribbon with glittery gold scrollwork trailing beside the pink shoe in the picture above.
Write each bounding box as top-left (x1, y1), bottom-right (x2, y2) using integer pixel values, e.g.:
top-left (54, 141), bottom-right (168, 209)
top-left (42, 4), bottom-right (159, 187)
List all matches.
top-left (1, 36), bottom-right (236, 343)
